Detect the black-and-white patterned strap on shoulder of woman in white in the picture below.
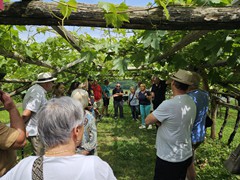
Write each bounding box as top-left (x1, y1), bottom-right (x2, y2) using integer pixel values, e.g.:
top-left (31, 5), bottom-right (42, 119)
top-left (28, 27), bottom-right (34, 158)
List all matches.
top-left (32, 156), bottom-right (43, 180)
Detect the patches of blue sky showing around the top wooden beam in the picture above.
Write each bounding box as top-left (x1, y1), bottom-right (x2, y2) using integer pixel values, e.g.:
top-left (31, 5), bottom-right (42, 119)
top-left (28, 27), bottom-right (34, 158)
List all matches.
top-left (18, 0), bottom-right (154, 42)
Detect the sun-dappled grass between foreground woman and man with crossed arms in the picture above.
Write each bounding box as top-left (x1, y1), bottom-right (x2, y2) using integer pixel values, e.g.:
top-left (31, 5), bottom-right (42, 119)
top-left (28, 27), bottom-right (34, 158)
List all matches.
top-left (98, 107), bottom-right (156, 180)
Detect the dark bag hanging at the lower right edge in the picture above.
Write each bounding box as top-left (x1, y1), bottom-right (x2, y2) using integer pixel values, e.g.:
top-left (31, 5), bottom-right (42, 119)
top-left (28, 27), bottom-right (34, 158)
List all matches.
top-left (224, 144), bottom-right (240, 174)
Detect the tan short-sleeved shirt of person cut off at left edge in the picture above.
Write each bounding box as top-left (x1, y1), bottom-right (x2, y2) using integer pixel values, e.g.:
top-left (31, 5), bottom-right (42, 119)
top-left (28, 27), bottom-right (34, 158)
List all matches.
top-left (0, 122), bottom-right (19, 177)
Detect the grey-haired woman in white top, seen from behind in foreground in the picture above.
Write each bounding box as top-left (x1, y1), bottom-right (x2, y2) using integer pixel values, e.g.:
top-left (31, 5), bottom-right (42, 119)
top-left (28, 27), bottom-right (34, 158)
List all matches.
top-left (2, 97), bottom-right (116, 180)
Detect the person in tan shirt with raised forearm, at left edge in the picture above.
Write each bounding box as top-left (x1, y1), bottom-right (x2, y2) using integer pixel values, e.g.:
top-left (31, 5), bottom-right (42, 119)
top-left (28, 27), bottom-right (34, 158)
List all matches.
top-left (0, 73), bottom-right (26, 177)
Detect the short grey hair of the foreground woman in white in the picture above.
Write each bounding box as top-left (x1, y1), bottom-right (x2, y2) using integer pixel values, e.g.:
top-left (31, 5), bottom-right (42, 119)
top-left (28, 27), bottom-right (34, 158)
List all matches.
top-left (37, 96), bottom-right (84, 148)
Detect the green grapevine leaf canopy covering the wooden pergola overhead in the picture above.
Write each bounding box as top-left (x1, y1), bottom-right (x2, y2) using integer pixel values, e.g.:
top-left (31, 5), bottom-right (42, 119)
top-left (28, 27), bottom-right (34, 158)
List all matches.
top-left (0, 0), bottom-right (240, 93)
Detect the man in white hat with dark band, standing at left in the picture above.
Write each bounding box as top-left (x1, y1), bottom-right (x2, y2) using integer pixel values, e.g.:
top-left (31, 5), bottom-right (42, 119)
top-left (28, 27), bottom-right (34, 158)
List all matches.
top-left (22, 72), bottom-right (57, 156)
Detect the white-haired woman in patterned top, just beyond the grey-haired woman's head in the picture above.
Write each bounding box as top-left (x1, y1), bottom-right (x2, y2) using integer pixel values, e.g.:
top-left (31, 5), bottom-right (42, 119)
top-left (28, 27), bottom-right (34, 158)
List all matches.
top-left (71, 89), bottom-right (97, 155)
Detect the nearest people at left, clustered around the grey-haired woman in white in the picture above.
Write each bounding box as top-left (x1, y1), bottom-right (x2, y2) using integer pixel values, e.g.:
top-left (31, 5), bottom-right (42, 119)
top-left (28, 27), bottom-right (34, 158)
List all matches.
top-left (0, 73), bottom-right (116, 180)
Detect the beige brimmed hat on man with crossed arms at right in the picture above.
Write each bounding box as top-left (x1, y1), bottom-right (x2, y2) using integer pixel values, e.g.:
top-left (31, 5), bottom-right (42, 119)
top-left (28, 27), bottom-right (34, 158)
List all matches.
top-left (167, 69), bottom-right (193, 85)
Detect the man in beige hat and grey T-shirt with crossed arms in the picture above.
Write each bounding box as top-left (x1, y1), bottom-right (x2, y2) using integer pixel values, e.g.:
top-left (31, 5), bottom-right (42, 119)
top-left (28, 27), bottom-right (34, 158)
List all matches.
top-left (145, 69), bottom-right (196, 180)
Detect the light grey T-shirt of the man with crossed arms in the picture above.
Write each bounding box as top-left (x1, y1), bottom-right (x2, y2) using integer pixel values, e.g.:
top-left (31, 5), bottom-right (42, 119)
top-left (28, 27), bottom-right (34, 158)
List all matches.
top-left (153, 94), bottom-right (196, 162)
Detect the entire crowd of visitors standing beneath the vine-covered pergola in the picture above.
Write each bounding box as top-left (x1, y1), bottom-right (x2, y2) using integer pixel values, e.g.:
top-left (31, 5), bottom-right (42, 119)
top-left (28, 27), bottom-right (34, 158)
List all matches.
top-left (0, 69), bottom-right (208, 180)
